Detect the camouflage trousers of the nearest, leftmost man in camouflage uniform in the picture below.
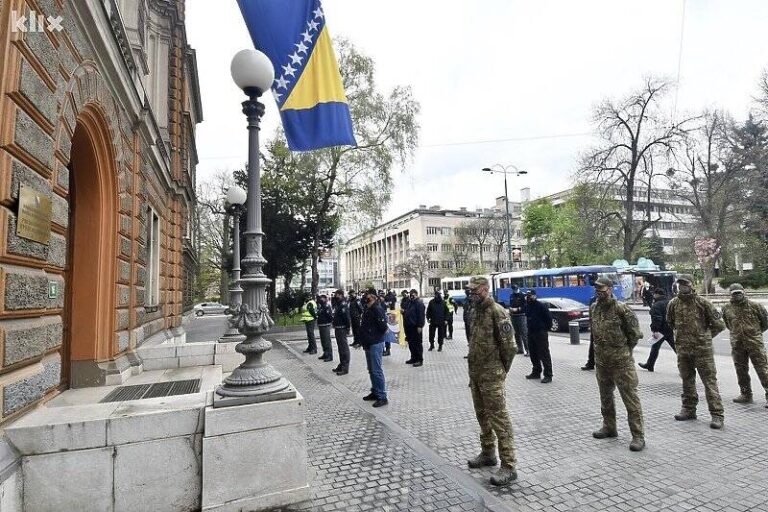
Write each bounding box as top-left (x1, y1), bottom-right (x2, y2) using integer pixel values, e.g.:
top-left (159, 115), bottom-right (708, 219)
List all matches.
top-left (470, 379), bottom-right (517, 469)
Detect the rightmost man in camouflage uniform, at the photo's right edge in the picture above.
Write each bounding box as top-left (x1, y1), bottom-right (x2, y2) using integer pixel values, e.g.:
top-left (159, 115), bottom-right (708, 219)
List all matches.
top-left (723, 283), bottom-right (768, 407)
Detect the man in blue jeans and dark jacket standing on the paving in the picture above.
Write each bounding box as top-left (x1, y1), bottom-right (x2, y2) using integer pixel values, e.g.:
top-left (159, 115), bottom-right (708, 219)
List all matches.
top-left (360, 288), bottom-right (389, 407)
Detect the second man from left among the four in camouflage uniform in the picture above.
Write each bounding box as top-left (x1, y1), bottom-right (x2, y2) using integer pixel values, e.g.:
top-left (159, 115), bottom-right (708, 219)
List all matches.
top-left (589, 277), bottom-right (645, 452)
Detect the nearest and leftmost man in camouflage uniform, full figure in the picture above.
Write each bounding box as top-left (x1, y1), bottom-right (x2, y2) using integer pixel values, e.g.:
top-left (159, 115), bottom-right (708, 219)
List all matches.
top-left (467, 277), bottom-right (517, 485)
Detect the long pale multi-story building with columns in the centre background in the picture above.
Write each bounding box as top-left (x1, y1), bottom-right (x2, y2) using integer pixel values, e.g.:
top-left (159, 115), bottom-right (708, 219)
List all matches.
top-left (341, 196), bottom-right (528, 292)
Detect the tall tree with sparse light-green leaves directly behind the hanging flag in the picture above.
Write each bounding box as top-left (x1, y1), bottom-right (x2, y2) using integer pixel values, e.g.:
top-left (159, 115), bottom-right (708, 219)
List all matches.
top-left (264, 39), bottom-right (420, 293)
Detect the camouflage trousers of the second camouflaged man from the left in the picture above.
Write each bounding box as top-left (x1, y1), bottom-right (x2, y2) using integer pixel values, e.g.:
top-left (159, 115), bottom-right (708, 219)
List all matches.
top-left (595, 359), bottom-right (645, 439)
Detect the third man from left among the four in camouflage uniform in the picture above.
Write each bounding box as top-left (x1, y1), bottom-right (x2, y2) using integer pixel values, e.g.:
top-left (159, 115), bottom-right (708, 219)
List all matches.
top-left (667, 274), bottom-right (725, 430)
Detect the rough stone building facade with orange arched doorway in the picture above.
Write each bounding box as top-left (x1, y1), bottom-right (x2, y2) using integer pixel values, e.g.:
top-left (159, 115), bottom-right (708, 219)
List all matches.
top-left (0, 0), bottom-right (202, 424)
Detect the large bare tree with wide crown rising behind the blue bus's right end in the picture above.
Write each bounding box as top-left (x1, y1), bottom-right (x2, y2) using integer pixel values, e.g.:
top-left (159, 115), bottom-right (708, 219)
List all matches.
top-left (579, 78), bottom-right (691, 260)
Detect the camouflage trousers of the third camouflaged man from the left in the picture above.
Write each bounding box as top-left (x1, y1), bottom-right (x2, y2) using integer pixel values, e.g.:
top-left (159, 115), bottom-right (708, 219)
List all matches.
top-left (677, 344), bottom-right (723, 418)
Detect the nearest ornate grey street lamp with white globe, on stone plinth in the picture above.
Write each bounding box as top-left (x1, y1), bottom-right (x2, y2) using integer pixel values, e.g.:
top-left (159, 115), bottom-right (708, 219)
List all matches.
top-left (214, 50), bottom-right (296, 407)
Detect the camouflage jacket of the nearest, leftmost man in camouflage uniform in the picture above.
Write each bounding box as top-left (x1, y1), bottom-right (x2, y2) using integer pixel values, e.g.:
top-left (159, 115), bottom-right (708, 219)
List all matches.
top-left (467, 297), bottom-right (517, 379)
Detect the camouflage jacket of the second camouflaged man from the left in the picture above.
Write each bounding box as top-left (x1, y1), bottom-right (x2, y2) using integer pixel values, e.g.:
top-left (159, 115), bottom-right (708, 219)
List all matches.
top-left (589, 298), bottom-right (643, 366)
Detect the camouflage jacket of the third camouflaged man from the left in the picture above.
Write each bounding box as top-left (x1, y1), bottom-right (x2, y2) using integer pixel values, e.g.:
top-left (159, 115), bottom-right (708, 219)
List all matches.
top-left (667, 292), bottom-right (725, 350)
